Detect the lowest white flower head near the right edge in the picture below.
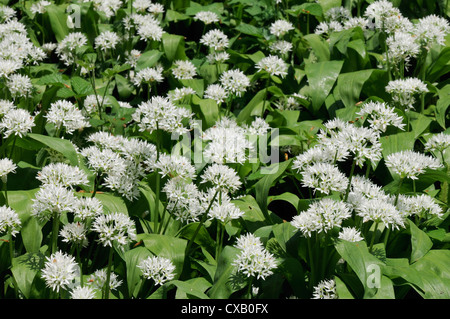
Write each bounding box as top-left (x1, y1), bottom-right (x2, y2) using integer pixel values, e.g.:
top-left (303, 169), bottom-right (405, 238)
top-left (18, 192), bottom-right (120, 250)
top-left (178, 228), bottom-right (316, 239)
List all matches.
top-left (397, 194), bottom-right (444, 219)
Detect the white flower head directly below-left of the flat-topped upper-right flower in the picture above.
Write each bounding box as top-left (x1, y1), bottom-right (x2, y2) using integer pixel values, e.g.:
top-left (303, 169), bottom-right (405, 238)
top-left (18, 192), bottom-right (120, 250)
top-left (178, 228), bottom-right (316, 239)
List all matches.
top-left (357, 101), bottom-right (405, 132)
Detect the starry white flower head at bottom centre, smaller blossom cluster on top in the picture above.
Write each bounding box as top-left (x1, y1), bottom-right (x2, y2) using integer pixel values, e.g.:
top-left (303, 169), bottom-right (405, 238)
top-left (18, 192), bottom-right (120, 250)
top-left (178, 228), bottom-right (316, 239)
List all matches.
top-left (232, 233), bottom-right (278, 280)
